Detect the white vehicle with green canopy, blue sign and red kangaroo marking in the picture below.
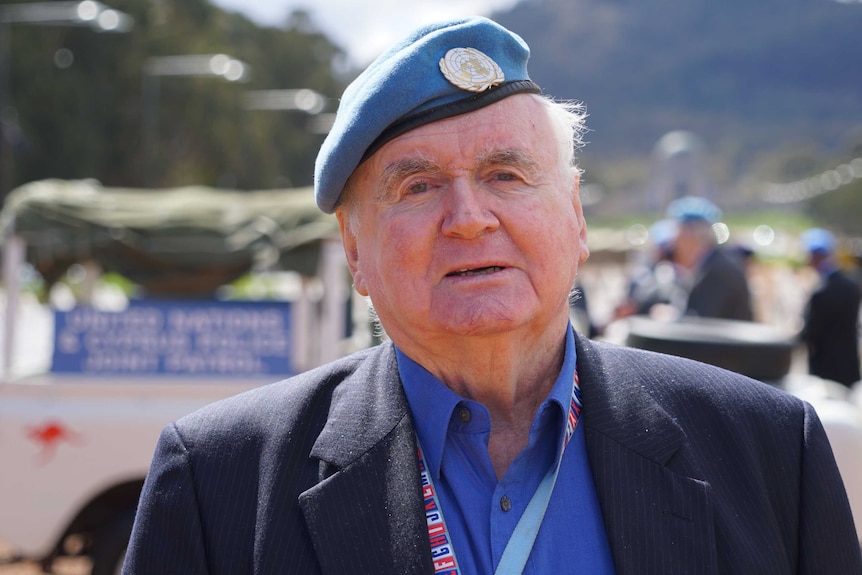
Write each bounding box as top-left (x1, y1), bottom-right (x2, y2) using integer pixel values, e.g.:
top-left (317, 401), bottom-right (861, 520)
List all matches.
top-left (0, 181), bottom-right (361, 575)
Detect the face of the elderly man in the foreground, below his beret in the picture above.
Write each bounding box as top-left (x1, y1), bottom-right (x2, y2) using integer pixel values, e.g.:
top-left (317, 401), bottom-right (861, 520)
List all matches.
top-left (338, 95), bottom-right (589, 348)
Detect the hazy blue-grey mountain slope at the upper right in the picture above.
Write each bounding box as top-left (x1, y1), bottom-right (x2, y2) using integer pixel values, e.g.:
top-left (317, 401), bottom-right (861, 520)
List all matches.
top-left (493, 0), bottom-right (862, 165)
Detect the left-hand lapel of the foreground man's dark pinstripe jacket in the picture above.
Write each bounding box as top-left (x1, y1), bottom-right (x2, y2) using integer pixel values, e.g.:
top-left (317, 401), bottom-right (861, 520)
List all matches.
top-left (299, 344), bottom-right (433, 575)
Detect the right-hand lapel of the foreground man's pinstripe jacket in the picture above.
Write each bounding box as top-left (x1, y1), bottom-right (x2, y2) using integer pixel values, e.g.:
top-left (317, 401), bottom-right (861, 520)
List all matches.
top-left (577, 336), bottom-right (716, 575)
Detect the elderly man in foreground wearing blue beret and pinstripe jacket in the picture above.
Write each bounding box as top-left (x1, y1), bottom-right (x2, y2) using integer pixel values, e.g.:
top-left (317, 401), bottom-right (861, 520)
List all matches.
top-left (124, 18), bottom-right (862, 575)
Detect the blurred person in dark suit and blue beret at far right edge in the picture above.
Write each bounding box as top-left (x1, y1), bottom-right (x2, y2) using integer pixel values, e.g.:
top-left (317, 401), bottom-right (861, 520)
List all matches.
top-left (800, 228), bottom-right (862, 386)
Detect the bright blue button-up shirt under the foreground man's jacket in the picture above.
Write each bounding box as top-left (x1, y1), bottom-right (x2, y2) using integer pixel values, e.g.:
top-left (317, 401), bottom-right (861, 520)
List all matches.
top-left (397, 326), bottom-right (614, 575)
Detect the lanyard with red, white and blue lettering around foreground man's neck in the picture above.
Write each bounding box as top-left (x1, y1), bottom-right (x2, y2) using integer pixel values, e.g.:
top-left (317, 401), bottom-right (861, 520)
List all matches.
top-left (416, 371), bottom-right (581, 575)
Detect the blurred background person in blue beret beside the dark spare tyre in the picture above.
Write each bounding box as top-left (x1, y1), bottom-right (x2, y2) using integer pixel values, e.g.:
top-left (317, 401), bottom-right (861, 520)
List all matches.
top-left (667, 196), bottom-right (754, 321)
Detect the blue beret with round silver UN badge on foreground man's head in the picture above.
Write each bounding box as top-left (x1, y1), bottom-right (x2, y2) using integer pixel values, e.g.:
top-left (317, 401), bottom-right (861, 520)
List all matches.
top-left (314, 17), bottom-right (541, 213)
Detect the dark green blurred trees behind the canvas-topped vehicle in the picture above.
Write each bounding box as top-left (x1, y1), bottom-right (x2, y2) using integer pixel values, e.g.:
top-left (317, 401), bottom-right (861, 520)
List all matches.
top-left (0, 0), bottom-right (352, 198)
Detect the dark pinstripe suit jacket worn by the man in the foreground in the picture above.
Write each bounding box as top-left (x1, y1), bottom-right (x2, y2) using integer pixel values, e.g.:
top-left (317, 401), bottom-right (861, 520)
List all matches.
top-left (125, 337), bottom-right (862, 575)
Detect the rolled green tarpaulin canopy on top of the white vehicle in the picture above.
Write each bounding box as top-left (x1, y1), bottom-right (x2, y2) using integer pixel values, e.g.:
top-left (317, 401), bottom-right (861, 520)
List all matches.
top-left (0, 180), bottom-right (338, 296)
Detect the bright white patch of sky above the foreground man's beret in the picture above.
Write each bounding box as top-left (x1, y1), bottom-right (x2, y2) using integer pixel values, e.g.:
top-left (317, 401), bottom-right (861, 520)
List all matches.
top-left (211, 0), bottom-right (518, 66)
